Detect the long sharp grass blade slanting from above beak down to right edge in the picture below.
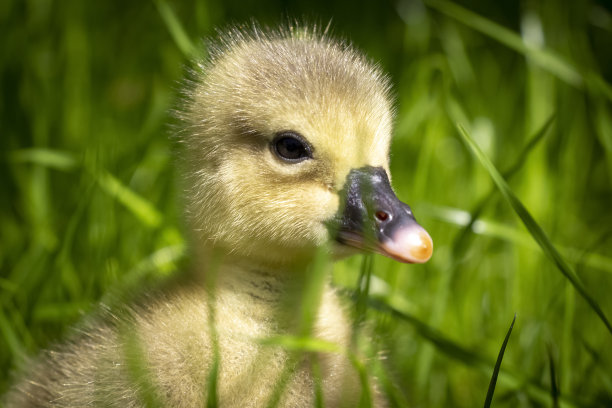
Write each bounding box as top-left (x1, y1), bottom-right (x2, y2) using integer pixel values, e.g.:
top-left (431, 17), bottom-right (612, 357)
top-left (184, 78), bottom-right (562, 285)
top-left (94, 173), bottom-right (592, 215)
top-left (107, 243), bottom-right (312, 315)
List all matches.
top-left (458, 125), bottom-right (612, 334)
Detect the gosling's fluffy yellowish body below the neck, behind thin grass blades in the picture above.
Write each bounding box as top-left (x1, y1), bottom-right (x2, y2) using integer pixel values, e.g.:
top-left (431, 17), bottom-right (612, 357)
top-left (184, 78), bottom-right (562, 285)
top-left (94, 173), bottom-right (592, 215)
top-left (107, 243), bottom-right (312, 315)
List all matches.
top-left (6, 267), bottom-right (360, 407)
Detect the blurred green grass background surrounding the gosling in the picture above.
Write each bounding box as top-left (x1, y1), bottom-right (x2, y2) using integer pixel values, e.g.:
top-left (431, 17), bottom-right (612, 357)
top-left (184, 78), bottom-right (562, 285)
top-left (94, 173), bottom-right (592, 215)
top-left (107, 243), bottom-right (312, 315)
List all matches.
top-left (0, 0), bottom-right (612, 407)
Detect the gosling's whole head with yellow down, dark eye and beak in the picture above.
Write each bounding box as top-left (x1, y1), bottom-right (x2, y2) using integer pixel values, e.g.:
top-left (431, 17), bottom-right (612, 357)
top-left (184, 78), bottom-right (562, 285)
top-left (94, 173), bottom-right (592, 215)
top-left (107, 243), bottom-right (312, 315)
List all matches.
top-left (180, 23), bottom-right (432, 268)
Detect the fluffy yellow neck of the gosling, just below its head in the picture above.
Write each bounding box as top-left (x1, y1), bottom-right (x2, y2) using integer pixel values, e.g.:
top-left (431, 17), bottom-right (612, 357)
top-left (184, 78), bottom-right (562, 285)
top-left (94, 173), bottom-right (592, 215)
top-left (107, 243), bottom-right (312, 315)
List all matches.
top-left (183, 242), bottom-right (350, 346)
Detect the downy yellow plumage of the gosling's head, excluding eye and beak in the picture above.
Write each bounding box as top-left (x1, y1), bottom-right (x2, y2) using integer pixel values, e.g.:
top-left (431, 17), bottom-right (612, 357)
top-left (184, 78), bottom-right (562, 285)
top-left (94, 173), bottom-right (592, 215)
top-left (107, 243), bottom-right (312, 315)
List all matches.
top-left (182, 24), bottom-right (392, 267)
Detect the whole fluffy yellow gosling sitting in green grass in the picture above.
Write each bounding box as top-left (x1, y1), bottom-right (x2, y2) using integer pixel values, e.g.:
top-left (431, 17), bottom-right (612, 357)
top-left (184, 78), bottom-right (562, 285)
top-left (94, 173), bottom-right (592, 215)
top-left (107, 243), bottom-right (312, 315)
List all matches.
top-left (5, 26), bottom-right (433, 408)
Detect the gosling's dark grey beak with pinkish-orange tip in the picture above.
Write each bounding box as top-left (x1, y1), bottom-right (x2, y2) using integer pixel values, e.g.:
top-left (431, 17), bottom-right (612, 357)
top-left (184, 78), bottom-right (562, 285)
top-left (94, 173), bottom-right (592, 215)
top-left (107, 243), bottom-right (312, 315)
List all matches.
top-left (335, 166), bottom-right (433, 263)
